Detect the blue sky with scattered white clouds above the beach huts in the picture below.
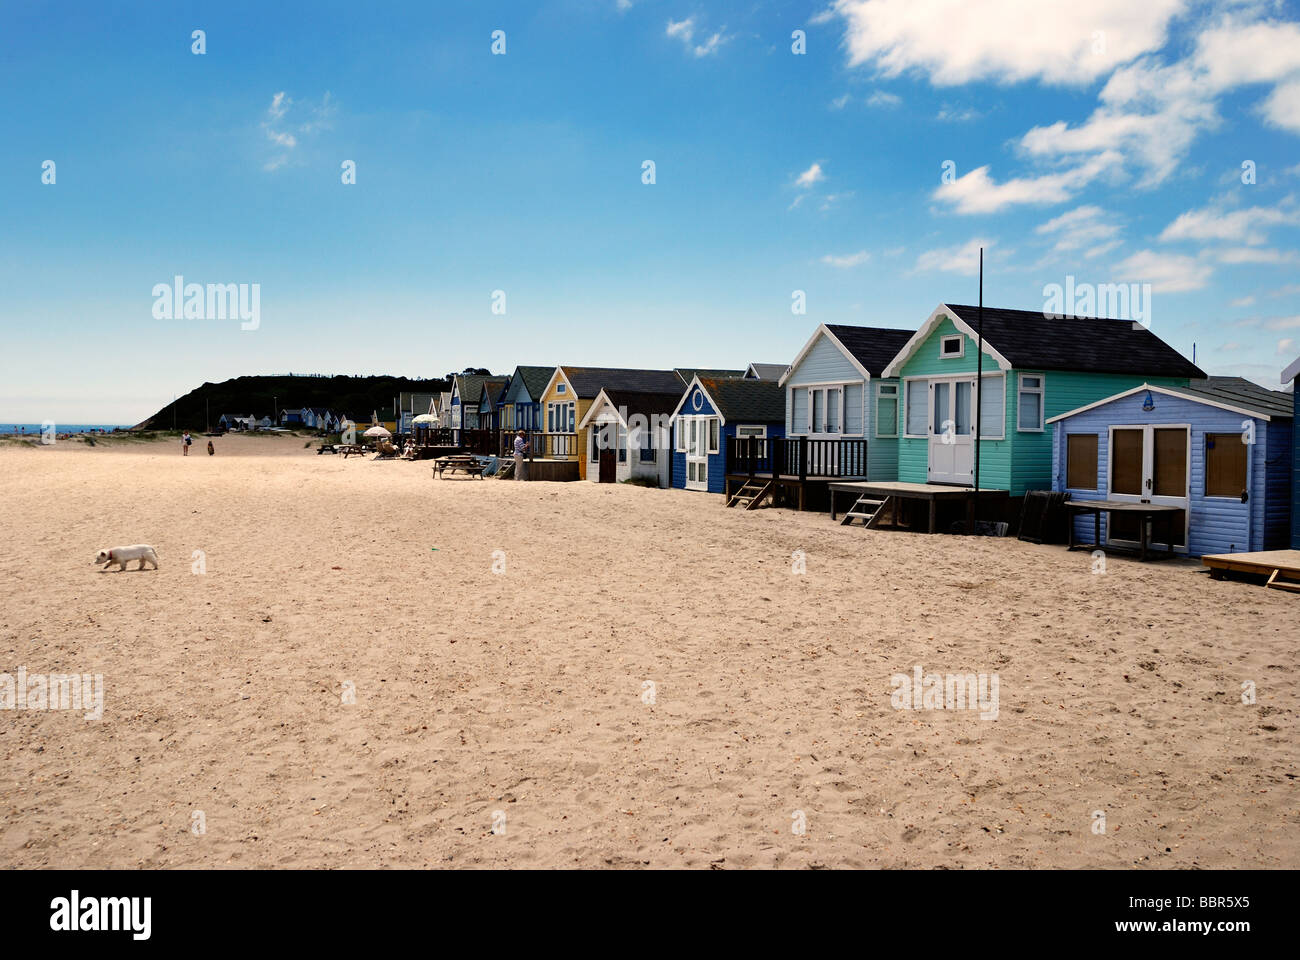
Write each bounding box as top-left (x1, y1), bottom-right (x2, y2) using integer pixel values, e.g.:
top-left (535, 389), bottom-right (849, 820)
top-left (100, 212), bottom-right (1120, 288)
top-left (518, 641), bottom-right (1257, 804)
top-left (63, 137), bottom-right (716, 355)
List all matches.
top-left (0, 0), bottom-right (1300, 423)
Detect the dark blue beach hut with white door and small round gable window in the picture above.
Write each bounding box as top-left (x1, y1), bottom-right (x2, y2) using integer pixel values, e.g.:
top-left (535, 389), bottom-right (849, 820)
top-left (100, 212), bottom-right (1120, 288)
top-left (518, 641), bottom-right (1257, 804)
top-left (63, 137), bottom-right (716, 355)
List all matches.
top-left (670, 377), bottom-right (785, 493)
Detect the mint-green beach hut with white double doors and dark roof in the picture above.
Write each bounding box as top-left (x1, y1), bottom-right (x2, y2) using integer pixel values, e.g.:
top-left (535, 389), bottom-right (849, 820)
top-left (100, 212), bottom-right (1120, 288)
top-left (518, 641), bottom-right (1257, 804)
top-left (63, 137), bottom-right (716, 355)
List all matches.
top-left (883, 303), bottom-right (1205, 496)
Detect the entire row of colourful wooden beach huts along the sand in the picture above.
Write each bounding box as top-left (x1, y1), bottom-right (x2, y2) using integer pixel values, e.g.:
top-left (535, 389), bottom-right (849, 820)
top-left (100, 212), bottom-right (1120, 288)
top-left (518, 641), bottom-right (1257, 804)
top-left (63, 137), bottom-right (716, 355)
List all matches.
top-left (394, 303), bottom-right (1300, 572)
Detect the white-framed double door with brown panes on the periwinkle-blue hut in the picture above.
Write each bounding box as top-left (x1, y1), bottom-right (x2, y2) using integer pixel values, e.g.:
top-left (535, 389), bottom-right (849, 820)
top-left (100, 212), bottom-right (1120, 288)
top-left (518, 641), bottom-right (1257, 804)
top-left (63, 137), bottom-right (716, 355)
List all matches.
top-left (1106, 424), bottom-right (1191, 550)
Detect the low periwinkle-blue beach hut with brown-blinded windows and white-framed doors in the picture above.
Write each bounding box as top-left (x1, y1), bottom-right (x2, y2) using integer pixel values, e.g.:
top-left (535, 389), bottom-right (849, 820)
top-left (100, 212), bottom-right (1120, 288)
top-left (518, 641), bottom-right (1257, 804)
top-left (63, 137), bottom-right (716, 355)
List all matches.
top-left (1047, 377), bottom-right (1295, 557)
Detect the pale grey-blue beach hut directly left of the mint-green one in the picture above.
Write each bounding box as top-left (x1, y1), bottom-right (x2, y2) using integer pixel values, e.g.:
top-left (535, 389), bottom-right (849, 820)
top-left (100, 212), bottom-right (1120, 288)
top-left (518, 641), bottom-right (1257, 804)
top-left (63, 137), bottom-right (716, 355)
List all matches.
top-left (780, 324), bottom-right (913, 480)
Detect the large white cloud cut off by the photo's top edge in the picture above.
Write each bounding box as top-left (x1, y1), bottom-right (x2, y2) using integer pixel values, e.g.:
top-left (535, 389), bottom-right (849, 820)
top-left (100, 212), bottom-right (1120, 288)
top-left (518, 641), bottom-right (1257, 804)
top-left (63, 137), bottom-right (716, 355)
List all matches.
top-left (835, 0), bottom-right (1186, 86)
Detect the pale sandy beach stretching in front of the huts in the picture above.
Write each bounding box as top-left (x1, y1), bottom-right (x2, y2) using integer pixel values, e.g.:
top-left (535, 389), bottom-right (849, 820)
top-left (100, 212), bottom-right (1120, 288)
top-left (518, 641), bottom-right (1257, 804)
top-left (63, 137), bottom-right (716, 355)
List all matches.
top-left (0, 437), bottom-right (1300, 869)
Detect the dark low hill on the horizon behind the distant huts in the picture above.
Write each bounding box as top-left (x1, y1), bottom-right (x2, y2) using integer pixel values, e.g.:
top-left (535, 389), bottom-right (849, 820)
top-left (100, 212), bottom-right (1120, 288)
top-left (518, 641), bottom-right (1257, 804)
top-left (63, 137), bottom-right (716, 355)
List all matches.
top-left (137, 373), bottom-right (451, 431)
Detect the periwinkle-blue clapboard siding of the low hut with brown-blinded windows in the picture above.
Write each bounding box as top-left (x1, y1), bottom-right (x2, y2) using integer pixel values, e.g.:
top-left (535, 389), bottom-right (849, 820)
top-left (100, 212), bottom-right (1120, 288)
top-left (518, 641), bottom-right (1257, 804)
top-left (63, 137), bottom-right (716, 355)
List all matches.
top-left (1052, 393), bottom-right (1291, 557)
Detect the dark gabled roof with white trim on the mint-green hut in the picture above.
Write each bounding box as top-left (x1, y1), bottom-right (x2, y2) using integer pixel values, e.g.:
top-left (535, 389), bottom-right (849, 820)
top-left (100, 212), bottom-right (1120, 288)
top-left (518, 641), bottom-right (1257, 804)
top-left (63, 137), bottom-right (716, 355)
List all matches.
top-left (885, 303), bottom-right (1205, 380)
